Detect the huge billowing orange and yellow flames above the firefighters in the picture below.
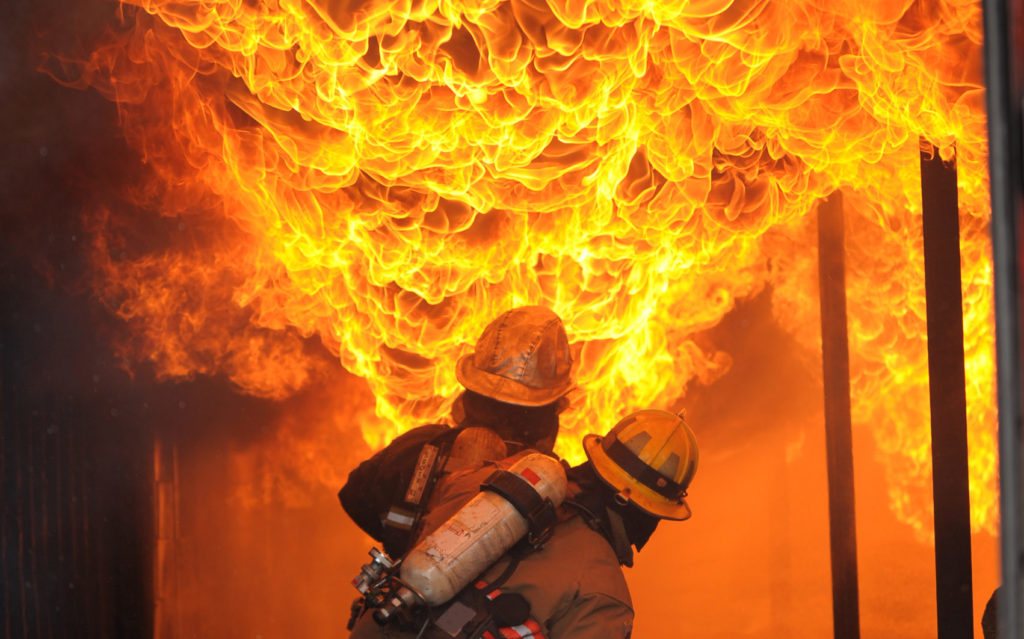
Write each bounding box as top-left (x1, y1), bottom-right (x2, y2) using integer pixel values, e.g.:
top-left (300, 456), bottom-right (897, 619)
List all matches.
top-left (51, 0), bottom-right (997, 529)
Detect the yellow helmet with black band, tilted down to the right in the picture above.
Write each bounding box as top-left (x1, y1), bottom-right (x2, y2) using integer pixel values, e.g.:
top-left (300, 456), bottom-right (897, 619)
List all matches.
top-left (583, 410), bottom-right (698, 520)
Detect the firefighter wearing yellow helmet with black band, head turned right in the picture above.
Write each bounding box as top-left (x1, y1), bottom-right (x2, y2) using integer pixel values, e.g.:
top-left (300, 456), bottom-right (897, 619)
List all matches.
top-left (351, 410), bottom-right (698, 639)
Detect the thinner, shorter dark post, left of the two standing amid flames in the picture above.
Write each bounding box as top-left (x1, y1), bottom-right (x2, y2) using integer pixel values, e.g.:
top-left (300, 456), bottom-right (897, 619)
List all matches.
top-left (818, 190), bottom-right (860, 639)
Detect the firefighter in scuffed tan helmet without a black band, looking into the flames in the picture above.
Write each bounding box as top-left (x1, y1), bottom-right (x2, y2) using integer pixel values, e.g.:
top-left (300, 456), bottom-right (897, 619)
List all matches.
top-left (338, 306), bottom-right (573, 556)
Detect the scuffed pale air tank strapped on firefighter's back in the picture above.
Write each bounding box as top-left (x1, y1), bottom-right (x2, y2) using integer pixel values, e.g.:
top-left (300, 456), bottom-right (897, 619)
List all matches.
top-left (400, 453), bottom-right (566, 605)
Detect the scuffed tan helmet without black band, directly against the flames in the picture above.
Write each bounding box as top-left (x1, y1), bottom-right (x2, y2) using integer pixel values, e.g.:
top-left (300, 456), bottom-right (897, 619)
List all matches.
top-left (456, 306), bottom-right (572, 407)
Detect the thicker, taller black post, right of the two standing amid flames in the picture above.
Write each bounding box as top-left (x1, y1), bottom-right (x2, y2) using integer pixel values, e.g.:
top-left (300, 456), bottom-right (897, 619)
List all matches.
top-left (921, 139), bottom-right (974, 639)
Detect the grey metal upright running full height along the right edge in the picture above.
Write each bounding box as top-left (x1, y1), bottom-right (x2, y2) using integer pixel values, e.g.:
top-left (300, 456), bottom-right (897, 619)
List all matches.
top-left (982, 0), bottom-right (1024, 637)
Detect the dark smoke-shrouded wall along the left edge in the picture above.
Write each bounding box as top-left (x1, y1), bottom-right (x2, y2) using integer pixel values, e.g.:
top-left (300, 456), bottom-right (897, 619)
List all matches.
top-left (0, 1), bottom-right (153, 638)
